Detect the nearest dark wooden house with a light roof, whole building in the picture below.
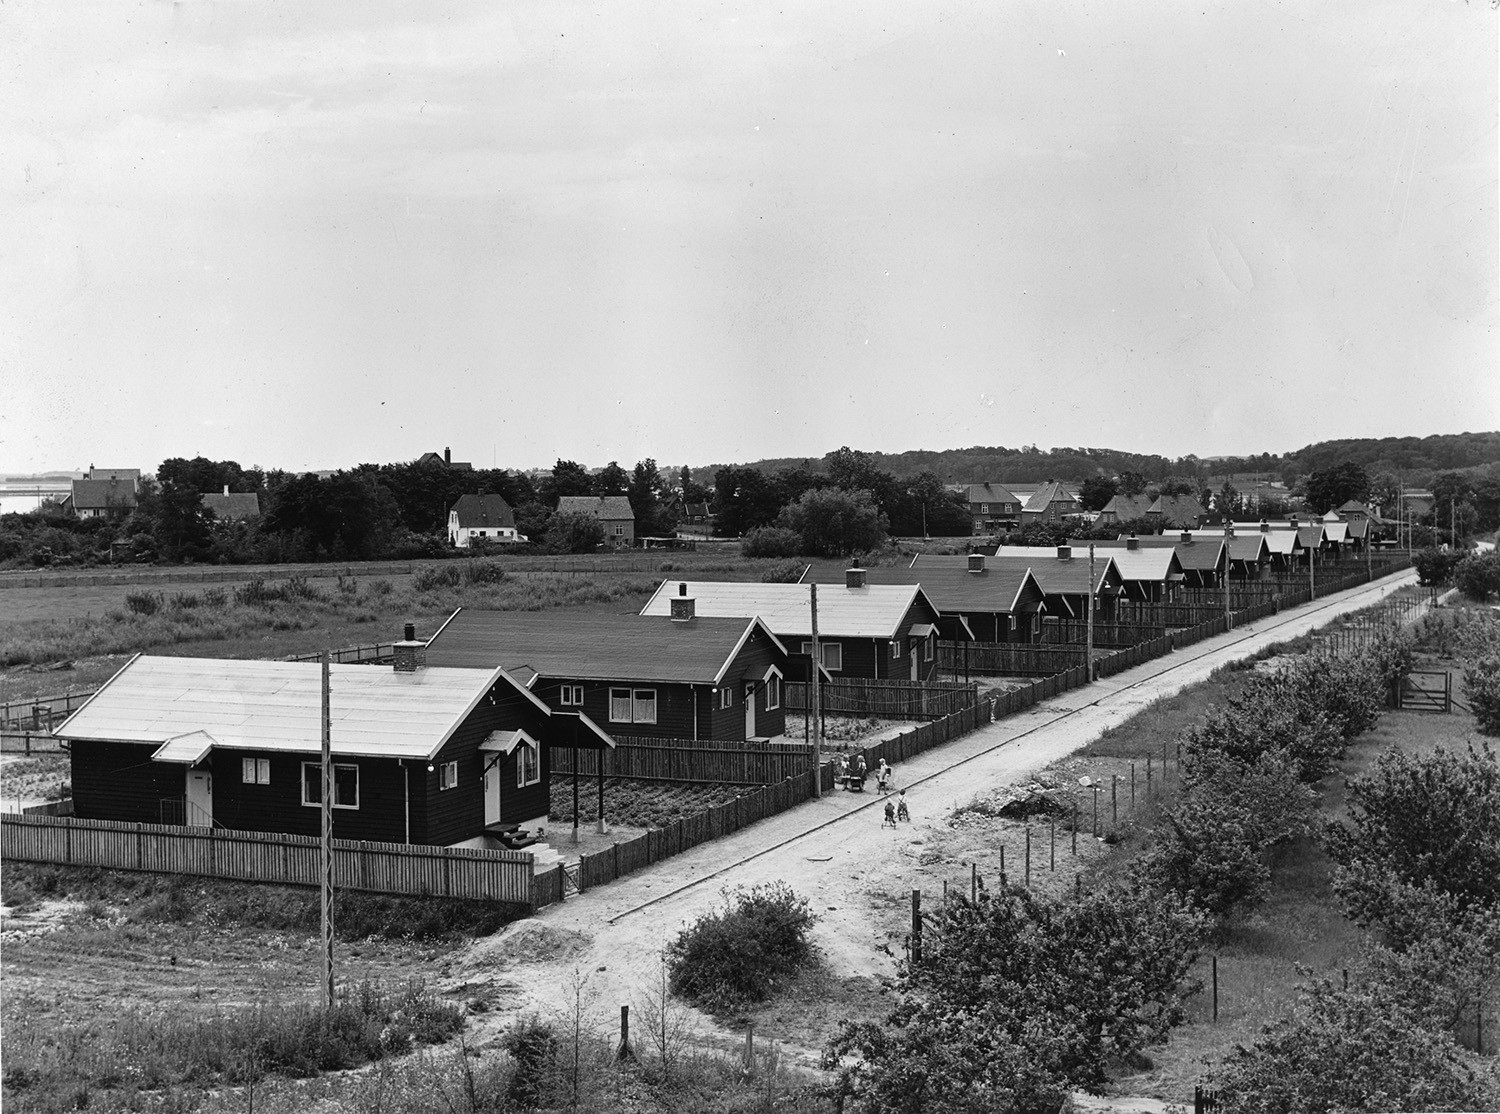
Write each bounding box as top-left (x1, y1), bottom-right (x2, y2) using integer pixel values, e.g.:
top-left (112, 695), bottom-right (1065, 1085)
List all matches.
top-left (54, 653), bottom-right (614, 846)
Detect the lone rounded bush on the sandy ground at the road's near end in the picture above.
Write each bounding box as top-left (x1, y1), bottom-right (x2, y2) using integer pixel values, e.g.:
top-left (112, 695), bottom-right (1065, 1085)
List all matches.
top-left (666, 882), bottom-right (818, 1014)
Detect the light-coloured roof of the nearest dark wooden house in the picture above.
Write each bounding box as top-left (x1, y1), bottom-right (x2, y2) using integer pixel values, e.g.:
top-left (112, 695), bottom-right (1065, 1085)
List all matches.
top-left (54, 655), bottom-right (533, 760)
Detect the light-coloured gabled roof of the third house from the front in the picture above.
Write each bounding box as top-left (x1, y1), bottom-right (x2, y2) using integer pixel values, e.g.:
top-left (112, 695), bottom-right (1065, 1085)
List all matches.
top-left (641, 580), bottom-right (939, 639)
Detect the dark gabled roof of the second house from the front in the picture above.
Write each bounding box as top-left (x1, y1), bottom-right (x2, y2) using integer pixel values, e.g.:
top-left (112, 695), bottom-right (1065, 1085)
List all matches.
top-left (428, 607), bottom-right (786, 687)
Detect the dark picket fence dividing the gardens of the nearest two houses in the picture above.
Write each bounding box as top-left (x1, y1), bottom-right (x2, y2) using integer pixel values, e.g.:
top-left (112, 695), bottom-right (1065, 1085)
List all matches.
top-left (552, 735), bottom-right (812, 786)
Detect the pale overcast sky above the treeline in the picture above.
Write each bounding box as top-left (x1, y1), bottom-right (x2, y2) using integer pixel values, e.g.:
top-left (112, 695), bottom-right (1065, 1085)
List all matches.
top-left (0, 0), bottom-right (1500, 471)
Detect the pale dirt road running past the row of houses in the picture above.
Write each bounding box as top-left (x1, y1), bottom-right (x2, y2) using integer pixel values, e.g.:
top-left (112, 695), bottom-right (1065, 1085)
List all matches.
top-left (450, 573), bottom-right (1416, 1056)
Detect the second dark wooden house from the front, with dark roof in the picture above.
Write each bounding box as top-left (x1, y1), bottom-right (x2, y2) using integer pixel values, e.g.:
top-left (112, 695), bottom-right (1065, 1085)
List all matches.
top-left (428, 597), bottom-right (789, 739)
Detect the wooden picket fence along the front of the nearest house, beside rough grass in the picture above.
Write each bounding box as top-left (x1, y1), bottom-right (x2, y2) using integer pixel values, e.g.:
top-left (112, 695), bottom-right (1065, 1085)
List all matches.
top-left (0, 813), bottom-right (536, 907)
